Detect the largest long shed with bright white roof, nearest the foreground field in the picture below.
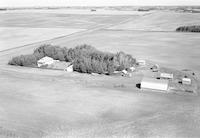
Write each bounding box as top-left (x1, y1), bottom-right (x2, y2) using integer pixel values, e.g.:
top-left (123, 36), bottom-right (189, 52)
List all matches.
top-left (140, 78), bottom-right (169, 91)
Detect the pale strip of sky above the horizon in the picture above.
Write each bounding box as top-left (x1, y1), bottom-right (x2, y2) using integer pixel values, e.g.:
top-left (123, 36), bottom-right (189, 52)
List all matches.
top-left (0, 0), bottom-right (200, 7)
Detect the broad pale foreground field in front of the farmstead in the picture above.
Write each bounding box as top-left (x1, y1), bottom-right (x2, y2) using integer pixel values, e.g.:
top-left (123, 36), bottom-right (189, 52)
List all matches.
top-left (0, 67), bottom-right (200, 138)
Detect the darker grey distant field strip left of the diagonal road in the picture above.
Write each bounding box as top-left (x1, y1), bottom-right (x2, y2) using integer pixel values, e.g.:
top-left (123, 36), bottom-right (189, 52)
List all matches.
top-left (0, 11), bottom-right (134, 29)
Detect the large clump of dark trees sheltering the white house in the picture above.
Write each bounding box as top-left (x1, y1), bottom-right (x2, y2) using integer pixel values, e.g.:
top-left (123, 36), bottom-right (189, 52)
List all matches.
top-left (9, 45), bottom-right (136, 74)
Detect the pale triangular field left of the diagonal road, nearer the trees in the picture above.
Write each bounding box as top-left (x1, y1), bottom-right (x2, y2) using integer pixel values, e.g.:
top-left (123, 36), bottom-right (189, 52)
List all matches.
top-left (0, 27), bottom-right (84, 51)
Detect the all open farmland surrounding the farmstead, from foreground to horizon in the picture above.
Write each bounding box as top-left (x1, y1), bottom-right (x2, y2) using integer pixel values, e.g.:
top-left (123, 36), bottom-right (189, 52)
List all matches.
top-left (0, 8), bottom-right (200, 138)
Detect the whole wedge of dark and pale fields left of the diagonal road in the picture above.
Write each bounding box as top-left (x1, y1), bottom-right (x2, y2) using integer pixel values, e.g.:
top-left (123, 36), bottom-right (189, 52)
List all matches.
top-left (0, 10), bottom-right (134, 51)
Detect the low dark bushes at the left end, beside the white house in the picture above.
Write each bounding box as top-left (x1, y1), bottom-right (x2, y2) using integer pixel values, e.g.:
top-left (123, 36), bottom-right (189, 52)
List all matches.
top-left (8, 55), bottom-right (37, 66)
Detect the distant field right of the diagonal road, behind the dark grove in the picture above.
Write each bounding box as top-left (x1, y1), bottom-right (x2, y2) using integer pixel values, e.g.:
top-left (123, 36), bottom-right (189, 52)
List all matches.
top-left (111, 11), bottom-right (200, 31)
